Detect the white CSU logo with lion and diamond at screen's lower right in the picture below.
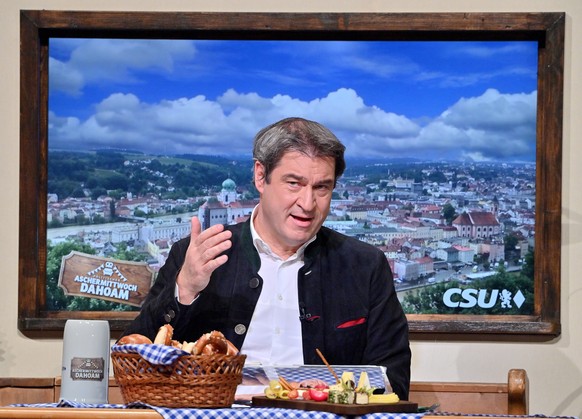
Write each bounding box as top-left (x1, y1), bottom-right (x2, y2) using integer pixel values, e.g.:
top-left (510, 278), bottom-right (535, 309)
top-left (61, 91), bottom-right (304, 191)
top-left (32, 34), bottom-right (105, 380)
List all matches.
top-left (443, 288), bottom-right (525, 308)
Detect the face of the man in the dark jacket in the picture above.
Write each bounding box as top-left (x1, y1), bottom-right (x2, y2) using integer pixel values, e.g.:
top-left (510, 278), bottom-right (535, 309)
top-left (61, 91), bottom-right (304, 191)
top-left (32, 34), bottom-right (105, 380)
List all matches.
top-left (254, 151), bottom-right (335, 259)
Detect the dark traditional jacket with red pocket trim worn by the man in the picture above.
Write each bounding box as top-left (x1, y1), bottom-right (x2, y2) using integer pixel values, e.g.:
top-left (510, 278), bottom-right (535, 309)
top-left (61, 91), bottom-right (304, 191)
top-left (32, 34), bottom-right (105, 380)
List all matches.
top-left (124, 221), bottom-right (411, 400)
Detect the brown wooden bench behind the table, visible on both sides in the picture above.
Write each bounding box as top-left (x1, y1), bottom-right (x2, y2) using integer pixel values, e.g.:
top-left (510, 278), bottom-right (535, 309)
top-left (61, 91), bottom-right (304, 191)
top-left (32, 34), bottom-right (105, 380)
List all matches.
top-left (0, 369), bottom-right (528, 415)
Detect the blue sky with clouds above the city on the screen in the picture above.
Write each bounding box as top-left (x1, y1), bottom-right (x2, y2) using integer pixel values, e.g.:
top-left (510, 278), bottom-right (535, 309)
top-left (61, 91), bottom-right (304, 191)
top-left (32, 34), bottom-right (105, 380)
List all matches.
top-left (49, 38), bottom-right (537, 162)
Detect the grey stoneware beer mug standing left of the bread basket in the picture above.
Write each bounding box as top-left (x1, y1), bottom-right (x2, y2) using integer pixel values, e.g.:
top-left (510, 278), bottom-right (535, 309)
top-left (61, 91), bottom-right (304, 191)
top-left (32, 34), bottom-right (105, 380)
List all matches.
top-left (60, 320), bottom-right (110, 404)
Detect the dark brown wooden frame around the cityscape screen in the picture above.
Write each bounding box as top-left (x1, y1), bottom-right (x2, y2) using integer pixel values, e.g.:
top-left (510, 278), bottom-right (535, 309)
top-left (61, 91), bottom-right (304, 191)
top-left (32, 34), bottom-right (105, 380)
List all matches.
top-left (18, 10), bottom-right (565, 340)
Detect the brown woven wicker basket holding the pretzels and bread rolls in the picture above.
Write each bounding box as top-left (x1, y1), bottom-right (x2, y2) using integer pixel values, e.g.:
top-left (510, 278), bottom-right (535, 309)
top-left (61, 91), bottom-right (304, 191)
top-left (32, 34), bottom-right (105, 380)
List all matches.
top-left (111, 352), bottom-right (246, 408)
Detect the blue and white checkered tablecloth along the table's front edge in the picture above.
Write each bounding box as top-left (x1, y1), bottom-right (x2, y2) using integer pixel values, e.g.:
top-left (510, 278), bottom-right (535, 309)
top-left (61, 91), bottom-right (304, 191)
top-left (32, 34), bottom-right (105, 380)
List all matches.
top-left (12, 400), bottom-right (423, 419)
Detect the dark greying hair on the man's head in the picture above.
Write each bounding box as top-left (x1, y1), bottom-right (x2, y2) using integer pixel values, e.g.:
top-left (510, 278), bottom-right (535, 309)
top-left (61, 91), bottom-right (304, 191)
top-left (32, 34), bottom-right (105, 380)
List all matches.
top-left (253, 118), bottom-right (346, 183)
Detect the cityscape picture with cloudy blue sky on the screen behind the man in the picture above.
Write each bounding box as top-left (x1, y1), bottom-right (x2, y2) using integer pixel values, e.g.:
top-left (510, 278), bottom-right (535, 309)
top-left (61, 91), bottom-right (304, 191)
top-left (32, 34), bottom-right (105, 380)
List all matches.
top-left (46, 38), bottom-right (537, 315)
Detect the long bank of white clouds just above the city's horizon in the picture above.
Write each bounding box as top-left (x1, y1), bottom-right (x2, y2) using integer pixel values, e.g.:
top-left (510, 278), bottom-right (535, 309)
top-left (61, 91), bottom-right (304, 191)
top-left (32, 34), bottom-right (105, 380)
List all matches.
top-left (49, 88), bottom-right (536, 161)
